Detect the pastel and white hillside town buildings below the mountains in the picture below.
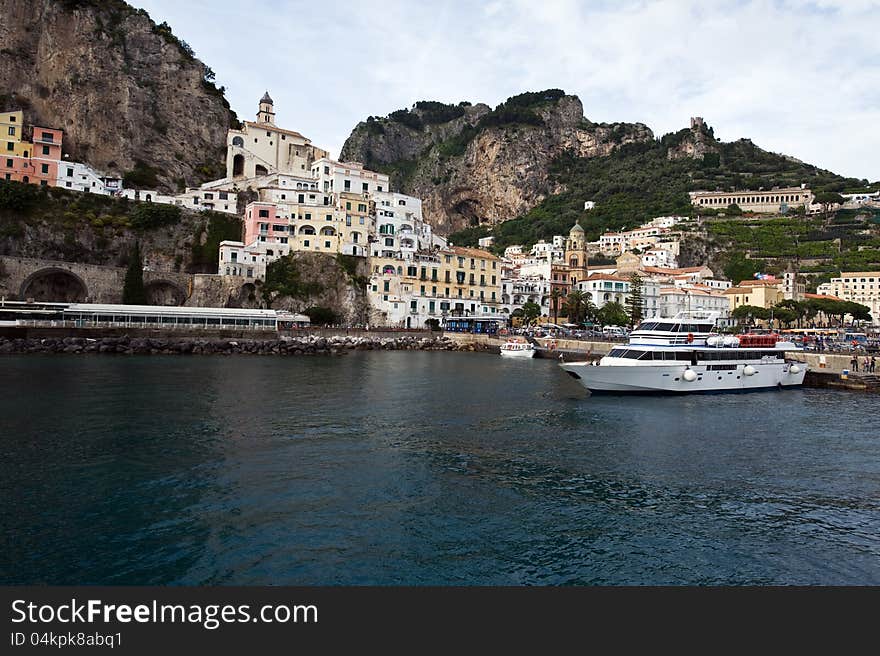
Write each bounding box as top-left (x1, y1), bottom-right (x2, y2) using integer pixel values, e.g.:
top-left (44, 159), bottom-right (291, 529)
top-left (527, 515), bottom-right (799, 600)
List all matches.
top-left (0, 92), bottom-right (880, 329)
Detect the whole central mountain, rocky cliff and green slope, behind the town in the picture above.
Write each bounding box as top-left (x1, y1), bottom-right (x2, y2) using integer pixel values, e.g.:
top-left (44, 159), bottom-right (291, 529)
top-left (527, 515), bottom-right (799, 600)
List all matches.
top-left (342, 89), bottom-right (867, 250)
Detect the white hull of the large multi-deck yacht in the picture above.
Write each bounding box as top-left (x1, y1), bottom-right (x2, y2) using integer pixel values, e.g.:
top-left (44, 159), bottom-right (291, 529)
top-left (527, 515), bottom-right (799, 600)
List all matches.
top-left (560, 362), bottom-right (807, 394)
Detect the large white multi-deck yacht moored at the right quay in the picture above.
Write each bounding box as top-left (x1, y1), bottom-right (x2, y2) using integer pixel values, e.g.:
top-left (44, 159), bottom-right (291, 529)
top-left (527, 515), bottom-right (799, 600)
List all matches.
top-left (560, 312), bottom-right (807, 393)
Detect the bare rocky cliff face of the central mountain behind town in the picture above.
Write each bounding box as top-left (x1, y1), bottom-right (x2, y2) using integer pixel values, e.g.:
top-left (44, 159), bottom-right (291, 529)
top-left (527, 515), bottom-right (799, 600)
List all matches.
top-left (341, 89), bottom-right (654, 234)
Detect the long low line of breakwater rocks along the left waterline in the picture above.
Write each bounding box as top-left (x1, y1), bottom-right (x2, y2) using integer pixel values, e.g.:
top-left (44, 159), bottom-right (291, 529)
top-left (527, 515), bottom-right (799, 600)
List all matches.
top-left (0, 335), bottom-right (497, 355)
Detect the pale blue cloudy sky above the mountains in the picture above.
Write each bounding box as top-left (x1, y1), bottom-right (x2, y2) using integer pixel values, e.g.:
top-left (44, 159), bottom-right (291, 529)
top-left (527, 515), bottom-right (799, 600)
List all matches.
top-left (136, 0), bottom-right (880, 181)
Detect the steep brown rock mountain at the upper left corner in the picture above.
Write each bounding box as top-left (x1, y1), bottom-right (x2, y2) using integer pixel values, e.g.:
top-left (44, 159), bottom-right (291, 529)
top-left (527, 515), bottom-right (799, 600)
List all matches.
top-left (0, 0), bottom-right (237, 189)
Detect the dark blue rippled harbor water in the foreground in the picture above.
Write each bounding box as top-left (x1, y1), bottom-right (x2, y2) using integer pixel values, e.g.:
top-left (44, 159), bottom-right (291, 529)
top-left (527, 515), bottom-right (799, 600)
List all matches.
top-left (0, 351), bottom-right (880, 585)
